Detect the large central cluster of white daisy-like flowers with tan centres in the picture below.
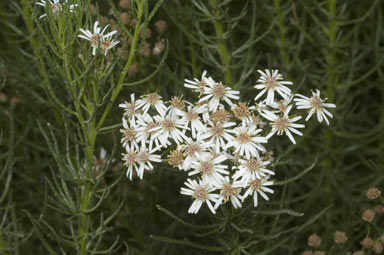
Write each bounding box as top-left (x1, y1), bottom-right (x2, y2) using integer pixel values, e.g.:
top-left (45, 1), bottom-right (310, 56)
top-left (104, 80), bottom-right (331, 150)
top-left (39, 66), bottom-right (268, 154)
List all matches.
top-left (119, 70), bottom-right (335, 213)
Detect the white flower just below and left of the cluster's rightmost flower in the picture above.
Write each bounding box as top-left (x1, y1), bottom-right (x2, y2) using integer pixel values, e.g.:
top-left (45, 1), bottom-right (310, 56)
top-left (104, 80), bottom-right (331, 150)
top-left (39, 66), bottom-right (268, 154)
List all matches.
top-left (261, 105), bottom-right (305, 144)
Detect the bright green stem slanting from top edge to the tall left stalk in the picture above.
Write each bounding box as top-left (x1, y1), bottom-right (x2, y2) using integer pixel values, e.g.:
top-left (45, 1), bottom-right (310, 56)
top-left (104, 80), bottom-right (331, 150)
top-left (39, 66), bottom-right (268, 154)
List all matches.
top-left (96, 0), bottom-right (145, 130)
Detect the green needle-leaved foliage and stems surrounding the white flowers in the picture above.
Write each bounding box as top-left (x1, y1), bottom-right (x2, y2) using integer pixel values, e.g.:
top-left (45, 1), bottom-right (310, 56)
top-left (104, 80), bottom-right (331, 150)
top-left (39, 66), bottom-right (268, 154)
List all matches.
top-left (0, 0), bottom-right (384, 255)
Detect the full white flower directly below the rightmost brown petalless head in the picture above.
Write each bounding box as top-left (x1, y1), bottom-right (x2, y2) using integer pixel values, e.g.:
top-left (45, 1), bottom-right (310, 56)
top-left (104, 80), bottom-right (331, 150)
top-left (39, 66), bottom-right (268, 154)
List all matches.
top-left (224, 125), bottom-right (268, 159)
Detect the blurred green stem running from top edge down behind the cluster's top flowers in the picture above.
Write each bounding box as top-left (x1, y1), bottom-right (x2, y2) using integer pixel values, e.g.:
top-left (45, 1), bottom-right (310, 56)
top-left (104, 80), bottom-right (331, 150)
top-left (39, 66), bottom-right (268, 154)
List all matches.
top-left (209, 0), bottom-right (232, 85)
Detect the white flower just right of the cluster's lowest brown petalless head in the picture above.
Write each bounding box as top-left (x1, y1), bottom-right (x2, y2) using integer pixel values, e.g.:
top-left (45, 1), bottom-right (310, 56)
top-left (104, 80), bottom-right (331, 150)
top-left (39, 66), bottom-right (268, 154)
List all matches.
top-left (180, 137), bottom-right (213, 171)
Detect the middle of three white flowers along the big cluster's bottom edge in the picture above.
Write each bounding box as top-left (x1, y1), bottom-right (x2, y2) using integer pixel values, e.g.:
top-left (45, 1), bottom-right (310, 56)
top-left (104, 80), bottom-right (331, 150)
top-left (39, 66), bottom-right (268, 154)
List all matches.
top-left (215, 176), bottom-right (242, 210)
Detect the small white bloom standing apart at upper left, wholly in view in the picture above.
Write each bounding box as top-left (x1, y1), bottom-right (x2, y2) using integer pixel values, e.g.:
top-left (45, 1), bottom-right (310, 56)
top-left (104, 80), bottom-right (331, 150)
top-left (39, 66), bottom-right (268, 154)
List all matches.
top-left (78, 21), bottom-right (120, 56)
